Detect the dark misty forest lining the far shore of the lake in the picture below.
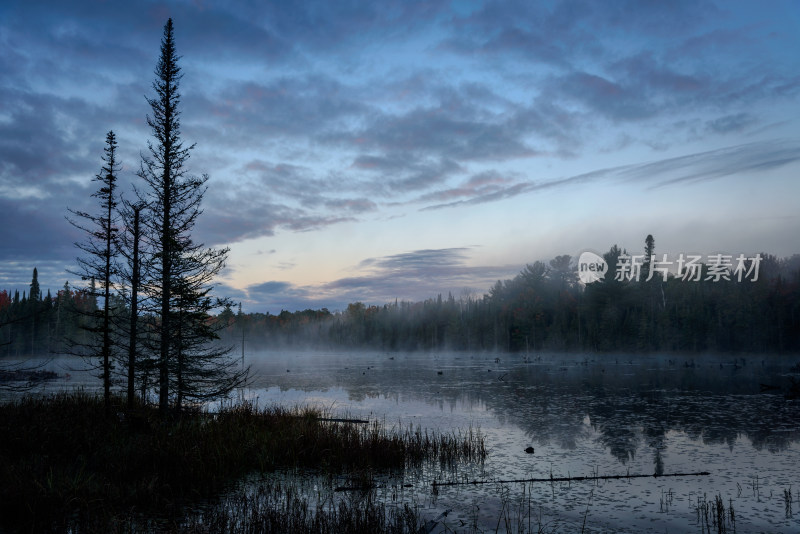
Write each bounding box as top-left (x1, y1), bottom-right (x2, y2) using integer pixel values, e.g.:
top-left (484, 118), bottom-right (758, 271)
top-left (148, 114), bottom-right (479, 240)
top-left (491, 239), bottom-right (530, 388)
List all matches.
top-left (6, 246), bottom-right (800, 356)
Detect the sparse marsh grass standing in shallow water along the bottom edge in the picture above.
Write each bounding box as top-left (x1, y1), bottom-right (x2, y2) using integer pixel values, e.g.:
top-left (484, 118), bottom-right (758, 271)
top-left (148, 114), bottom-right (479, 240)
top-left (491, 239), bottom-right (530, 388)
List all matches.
top-left (181, 473), bottom-right (568, 534)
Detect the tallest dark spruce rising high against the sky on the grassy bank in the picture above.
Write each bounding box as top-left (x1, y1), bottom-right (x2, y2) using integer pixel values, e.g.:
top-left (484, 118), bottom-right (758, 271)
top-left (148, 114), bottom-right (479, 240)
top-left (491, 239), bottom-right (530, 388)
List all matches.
top-left (139, 19), bottom-right (244, 413)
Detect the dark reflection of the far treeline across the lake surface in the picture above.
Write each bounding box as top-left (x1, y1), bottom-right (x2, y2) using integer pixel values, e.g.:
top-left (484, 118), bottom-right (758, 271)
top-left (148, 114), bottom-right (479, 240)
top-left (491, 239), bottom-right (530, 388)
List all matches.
top-left (248, 356), bottom-right (800, 462)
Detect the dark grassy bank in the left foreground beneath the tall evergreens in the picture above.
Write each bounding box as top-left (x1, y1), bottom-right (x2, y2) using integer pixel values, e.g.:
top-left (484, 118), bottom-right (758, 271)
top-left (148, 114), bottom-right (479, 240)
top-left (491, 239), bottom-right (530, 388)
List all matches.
top-left (0, 393), bottom-right (486, 532)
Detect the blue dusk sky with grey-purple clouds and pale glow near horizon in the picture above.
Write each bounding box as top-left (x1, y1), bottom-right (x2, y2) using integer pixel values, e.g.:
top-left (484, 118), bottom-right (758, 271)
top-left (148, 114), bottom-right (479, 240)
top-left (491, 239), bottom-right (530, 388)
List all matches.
top-left (0, 0), bottom-right (800, 313)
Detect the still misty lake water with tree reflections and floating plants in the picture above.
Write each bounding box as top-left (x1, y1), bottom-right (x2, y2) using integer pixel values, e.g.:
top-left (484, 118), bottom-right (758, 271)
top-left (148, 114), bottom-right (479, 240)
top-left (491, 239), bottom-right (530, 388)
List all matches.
top-left (10, 351), bottom-right (800, 532)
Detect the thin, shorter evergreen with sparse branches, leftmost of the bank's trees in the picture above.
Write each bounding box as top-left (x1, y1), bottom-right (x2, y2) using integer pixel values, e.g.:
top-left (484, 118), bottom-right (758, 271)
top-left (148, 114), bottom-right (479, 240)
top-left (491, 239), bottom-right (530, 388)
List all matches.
top-left (67, 131), bottom-right (120, 405)
